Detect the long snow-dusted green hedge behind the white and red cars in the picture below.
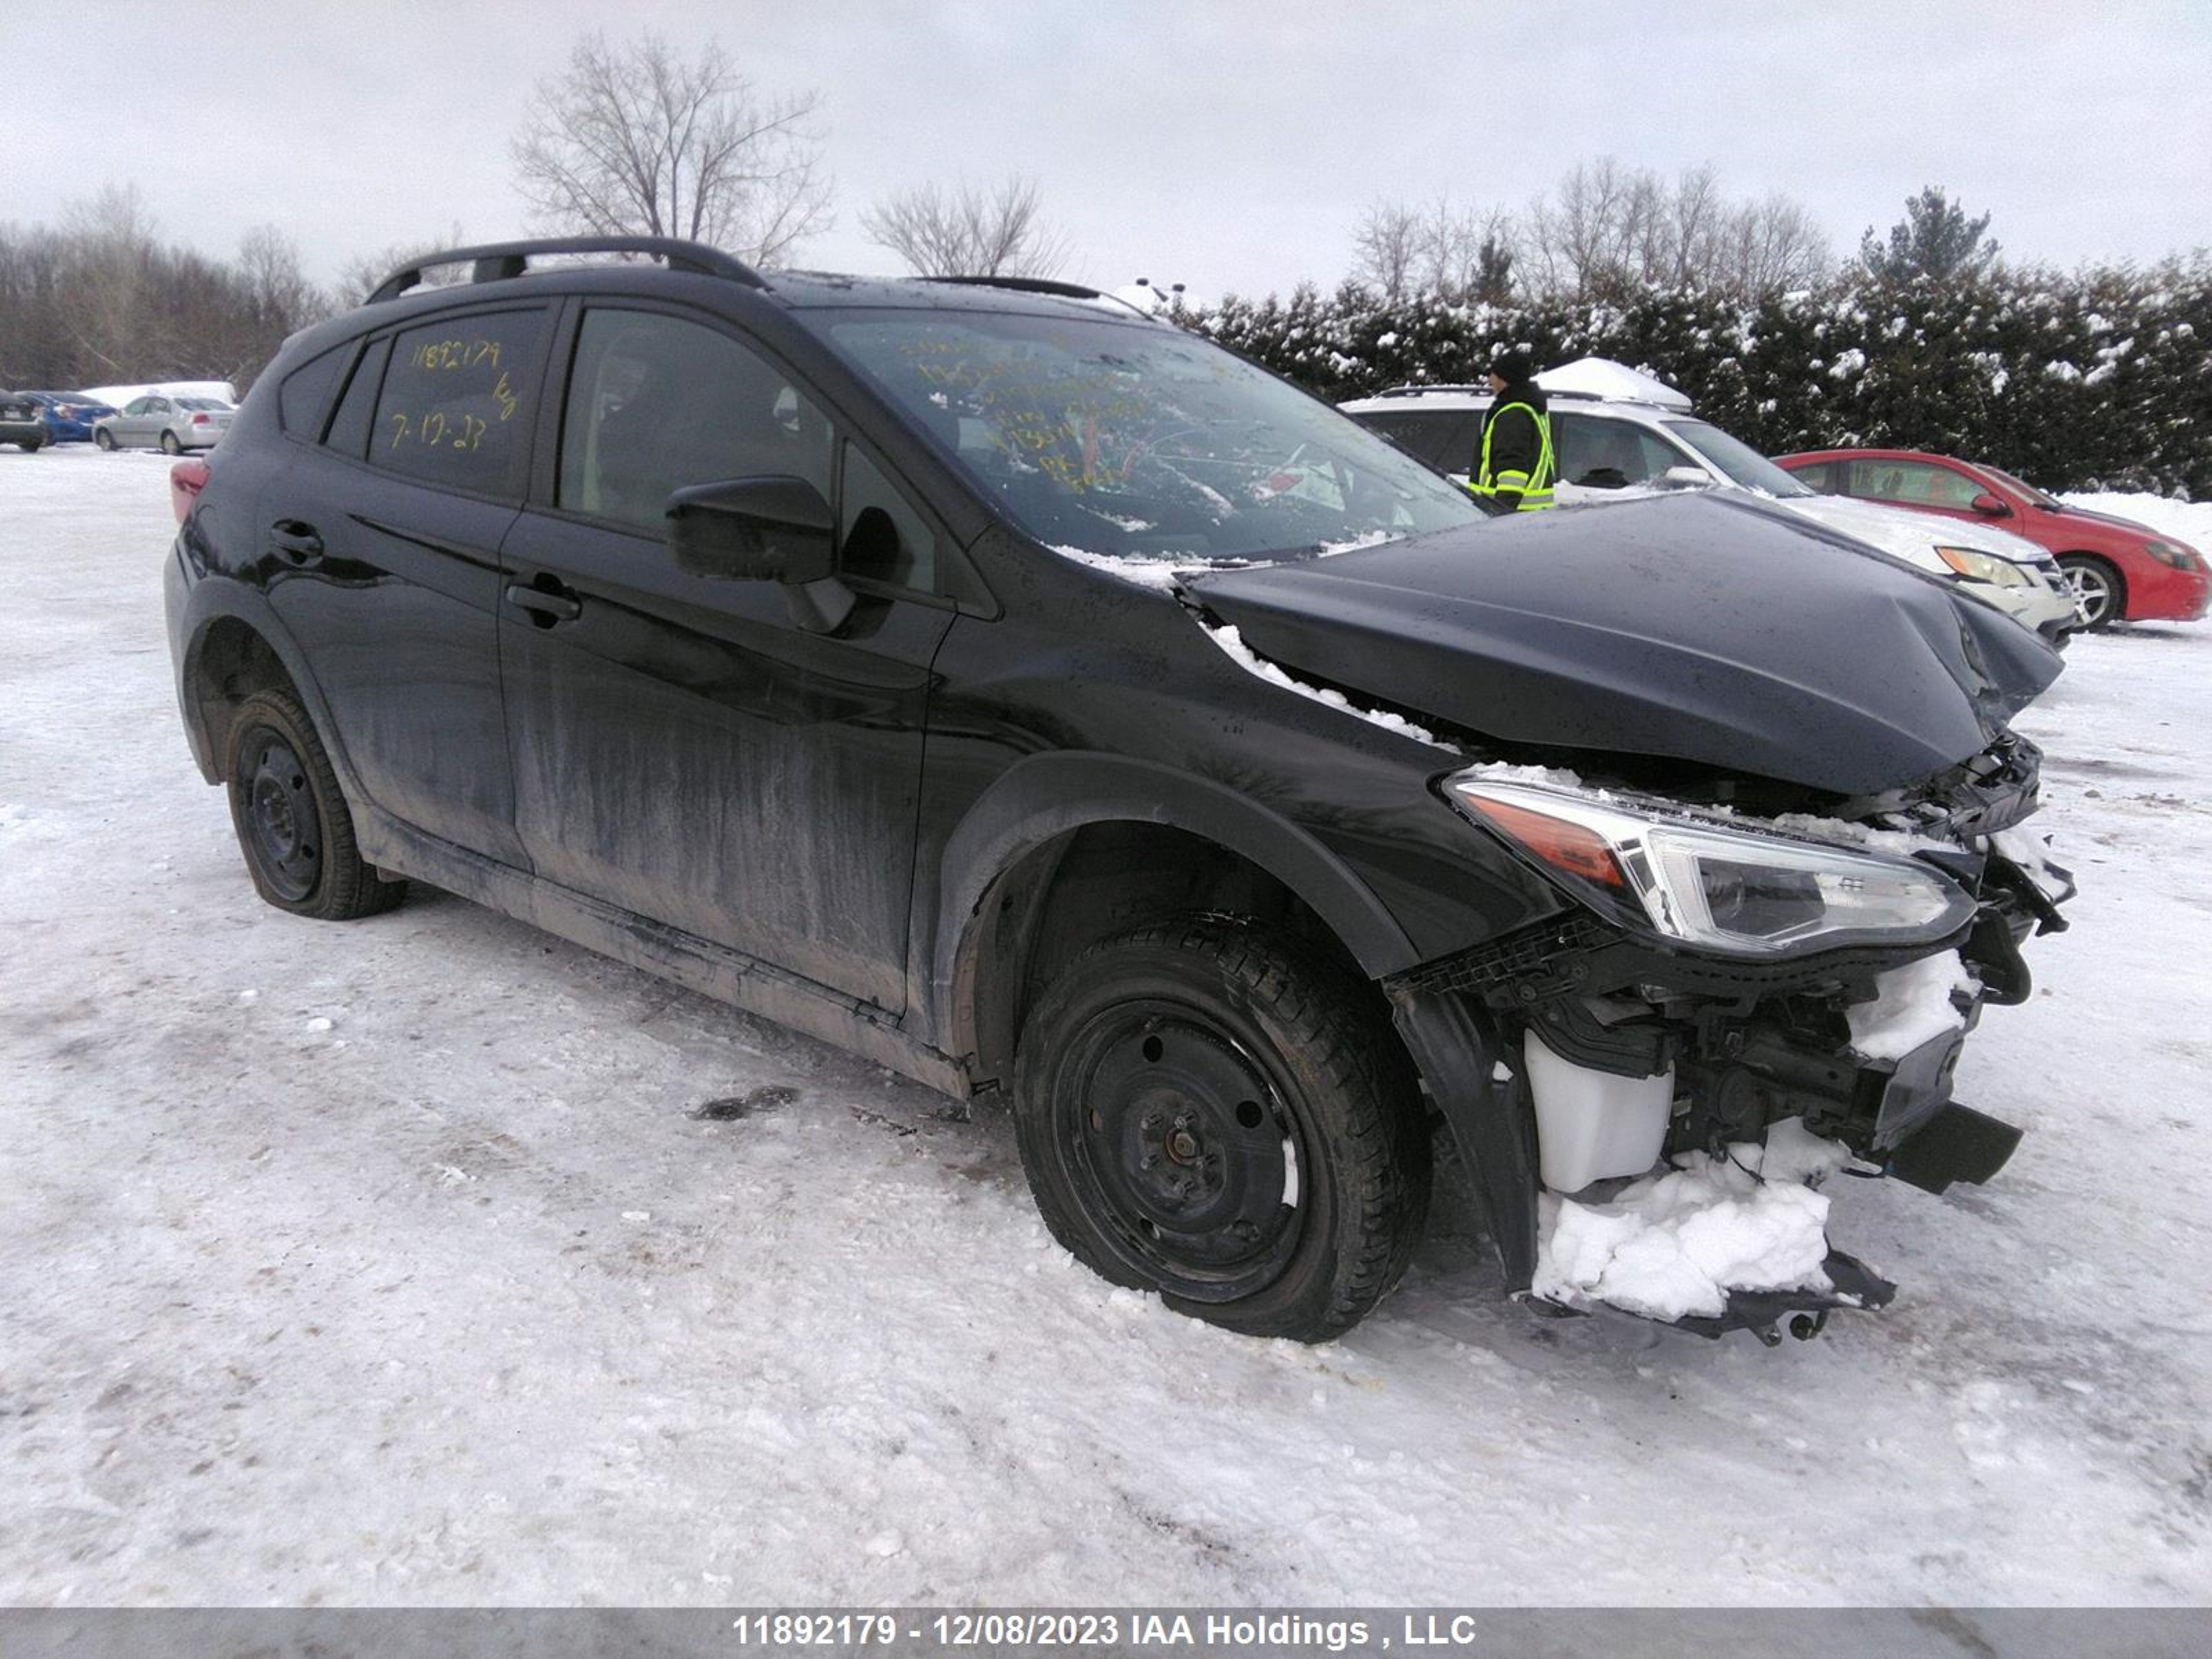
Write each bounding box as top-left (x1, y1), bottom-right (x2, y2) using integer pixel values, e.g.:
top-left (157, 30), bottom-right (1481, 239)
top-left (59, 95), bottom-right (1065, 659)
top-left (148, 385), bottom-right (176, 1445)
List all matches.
top-left (1179, 254), bottom-right (2212, 500)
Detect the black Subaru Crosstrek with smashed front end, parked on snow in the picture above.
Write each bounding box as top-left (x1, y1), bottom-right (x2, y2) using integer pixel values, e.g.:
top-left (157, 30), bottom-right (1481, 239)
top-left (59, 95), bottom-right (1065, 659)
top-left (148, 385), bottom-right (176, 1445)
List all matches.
top-left (166, 239), bottom-right (2070, 1338)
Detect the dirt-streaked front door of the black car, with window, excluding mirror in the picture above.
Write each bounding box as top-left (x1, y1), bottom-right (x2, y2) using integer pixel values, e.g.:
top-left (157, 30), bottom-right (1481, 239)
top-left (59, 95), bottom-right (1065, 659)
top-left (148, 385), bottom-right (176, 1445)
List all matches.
top-left (500, 306), bottom-right (953, 1013)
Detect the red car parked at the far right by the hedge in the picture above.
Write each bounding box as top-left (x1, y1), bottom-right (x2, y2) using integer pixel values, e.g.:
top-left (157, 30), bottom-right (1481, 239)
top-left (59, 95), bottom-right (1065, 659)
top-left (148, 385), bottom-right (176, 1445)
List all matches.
top-left (1774, 449), bottom-right (2212, 628)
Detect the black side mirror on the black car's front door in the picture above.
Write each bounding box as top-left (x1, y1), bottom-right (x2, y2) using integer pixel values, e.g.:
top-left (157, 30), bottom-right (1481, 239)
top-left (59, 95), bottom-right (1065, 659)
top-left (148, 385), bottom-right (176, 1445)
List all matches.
top-left (664, 476), bottom-right (854, 632)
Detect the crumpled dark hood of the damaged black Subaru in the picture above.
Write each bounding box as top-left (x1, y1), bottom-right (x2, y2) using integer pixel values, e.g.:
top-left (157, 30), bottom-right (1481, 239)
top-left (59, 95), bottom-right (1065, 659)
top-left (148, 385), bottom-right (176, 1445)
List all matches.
top-left (1185, 491), bottom-right (2059, 794)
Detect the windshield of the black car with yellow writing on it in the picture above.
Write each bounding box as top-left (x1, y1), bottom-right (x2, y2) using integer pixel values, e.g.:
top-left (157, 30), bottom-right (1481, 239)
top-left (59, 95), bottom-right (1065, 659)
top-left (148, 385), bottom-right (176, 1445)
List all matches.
top-left (830, 312), bottom-right (1482, 562)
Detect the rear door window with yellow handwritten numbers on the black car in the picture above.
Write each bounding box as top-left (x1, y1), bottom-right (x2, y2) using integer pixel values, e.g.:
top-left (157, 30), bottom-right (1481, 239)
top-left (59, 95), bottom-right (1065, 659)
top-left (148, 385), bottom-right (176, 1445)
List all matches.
top-left (369, 310), bottom-right (544, 496)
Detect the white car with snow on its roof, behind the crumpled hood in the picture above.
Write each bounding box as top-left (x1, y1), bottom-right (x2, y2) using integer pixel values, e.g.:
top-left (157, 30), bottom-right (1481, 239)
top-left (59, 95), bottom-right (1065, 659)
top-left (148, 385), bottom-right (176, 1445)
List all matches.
top-left (1342, 373), bottom-right (2081, 644)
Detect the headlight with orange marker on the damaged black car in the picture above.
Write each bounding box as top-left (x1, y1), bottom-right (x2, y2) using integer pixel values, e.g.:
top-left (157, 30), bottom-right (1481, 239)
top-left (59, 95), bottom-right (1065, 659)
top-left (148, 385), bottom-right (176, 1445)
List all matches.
top-left (1445, 772), bottom-right (1976, 955)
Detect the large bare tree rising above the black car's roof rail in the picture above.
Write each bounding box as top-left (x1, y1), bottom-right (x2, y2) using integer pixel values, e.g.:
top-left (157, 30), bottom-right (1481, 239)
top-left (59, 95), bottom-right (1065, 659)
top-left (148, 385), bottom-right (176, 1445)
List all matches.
top-left (509, 31), bottom-right (830, 265)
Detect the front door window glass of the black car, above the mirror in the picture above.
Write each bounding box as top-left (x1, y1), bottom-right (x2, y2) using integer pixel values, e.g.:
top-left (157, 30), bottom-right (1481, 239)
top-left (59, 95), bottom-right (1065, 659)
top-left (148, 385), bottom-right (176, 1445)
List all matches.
top-left (555, 308), bottom-right (832, 535)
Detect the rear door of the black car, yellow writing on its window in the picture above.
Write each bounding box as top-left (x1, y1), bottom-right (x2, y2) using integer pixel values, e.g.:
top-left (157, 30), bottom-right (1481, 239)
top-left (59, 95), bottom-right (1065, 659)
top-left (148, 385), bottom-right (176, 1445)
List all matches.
top-left (256, 303), bottom-right (553, 865)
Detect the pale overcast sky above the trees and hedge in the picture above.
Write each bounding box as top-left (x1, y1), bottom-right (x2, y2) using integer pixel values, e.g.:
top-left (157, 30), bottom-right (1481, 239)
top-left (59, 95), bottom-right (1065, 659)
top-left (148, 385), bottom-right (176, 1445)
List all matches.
top-left (0, 0), bottom-right (2212, 297)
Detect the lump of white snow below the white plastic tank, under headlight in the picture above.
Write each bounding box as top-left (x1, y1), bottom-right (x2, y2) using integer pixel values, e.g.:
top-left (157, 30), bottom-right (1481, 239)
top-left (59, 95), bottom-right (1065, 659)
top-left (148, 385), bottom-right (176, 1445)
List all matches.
top-left (1533, 1117), bottom-right (1849, 1318)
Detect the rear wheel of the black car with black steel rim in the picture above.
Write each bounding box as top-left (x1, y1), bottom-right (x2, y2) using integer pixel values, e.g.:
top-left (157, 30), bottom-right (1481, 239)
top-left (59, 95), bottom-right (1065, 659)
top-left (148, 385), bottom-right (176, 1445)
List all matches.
top-left (223, 690), bottom-right (407, 922)
